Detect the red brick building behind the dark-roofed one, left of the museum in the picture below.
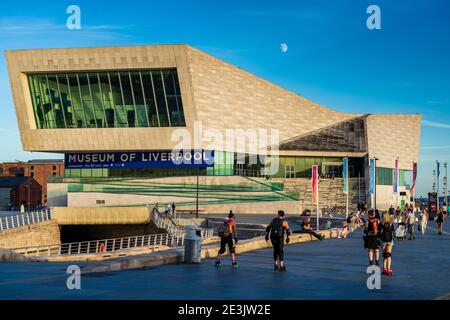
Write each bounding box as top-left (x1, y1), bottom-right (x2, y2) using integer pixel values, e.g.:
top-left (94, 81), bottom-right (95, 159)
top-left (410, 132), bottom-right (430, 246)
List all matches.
top-left (0, 159), bottom-right (64, 208)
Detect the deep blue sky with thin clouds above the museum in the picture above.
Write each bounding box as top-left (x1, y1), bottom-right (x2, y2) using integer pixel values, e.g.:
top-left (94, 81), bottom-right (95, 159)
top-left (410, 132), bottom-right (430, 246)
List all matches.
top-left (0, 0), bottom-right (450, 194)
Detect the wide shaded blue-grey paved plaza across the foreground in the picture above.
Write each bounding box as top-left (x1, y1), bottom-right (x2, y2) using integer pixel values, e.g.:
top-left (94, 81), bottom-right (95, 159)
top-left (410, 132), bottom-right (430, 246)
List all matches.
top-left (0, 221), bottom-right (450, 300)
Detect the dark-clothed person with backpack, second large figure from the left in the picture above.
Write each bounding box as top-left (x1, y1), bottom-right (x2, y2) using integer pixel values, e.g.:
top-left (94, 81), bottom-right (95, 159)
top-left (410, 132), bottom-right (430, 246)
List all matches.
top-left (266, 210), bottom-right (291, 271)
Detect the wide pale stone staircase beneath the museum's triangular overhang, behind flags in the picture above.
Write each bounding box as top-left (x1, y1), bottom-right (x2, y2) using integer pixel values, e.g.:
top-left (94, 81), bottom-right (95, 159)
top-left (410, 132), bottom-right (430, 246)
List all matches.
top-left (275, 178), bottom-right (366, 211)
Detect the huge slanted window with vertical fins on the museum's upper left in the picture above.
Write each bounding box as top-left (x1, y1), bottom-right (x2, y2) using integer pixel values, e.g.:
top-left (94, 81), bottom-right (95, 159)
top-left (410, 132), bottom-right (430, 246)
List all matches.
top-left (28, 69), bottom-right (186, 129)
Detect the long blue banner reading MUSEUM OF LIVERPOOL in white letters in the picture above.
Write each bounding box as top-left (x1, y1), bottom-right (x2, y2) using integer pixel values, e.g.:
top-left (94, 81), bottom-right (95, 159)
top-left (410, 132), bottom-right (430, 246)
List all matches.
top-left (64, 150), bottom-right (214, 169)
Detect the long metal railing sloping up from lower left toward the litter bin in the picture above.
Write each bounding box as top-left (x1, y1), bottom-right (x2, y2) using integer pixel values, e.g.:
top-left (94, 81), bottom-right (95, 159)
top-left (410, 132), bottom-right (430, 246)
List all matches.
top-left (14, 233), bottom-right (184, 257)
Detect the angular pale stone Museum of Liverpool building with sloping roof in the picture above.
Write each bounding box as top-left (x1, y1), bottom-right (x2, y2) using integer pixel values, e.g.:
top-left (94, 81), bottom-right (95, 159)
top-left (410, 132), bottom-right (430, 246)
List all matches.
top-left (6, 45), bottom-right (421, 213)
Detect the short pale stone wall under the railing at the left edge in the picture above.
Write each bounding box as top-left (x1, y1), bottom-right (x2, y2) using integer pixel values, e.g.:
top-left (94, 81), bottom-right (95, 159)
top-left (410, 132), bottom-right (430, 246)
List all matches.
top-left (0, 220), bottom-right (61, 249)
